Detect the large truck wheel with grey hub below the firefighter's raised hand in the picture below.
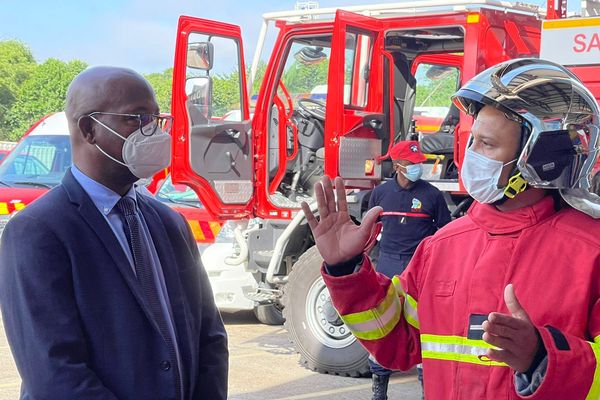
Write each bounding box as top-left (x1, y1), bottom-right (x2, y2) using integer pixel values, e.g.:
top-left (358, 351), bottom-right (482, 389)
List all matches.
top-left (283, 246), bottom-right (369, 377)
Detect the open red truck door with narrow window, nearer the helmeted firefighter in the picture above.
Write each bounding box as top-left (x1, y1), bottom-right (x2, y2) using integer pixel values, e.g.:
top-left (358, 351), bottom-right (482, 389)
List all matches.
top-left (325, 10), bottom-right (393, 188)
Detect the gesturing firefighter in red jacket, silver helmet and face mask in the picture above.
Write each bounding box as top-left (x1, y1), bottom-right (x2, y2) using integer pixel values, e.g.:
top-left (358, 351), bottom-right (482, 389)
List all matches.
top-left (303, 59), bottom-right (600, 400)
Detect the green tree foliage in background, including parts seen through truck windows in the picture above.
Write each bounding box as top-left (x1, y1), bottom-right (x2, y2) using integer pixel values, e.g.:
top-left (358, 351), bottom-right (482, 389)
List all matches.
top-left (0, 40), bottom-right (458, 141)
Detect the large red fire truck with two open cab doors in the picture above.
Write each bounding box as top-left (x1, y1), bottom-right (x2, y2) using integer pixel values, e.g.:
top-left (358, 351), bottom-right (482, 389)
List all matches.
top-left (172, 0), bottom-right (600, 376)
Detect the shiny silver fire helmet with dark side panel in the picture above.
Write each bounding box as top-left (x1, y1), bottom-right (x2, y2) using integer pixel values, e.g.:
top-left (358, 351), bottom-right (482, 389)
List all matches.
top-left (452, 58), bottom-right (600, 218)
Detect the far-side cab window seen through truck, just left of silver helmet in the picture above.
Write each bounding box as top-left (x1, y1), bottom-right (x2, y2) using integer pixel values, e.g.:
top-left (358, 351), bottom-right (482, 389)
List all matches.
top-left (413, 63), bottom-right (459, 133)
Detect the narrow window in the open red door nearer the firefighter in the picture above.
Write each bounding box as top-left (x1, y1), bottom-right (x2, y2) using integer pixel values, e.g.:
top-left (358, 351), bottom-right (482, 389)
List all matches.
top-left (344, 32), bottom-right (373, 108)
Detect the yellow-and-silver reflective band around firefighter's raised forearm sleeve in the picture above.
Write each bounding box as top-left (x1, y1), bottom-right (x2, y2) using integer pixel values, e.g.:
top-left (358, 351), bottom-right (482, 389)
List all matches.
top-left (340, 285), bottom-right (402, 340)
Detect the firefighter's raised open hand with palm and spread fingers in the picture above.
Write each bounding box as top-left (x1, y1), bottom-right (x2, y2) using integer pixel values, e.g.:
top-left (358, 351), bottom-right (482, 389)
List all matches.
top-left (302, 176), bottom-right (381, 265)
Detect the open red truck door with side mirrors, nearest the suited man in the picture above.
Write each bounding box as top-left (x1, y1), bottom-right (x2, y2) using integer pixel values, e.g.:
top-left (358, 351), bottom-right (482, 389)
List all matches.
top-left (171, 16), bottom-right (254, 219)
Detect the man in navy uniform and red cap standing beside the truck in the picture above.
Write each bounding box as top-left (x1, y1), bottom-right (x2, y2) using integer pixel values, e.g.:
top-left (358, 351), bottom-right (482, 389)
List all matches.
top-left (369, 141), bottom-right (450, 400)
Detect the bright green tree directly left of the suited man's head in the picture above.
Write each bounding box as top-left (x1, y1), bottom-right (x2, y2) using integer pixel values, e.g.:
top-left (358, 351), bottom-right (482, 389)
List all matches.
top-left (6, 58), bottom-right (87, 140)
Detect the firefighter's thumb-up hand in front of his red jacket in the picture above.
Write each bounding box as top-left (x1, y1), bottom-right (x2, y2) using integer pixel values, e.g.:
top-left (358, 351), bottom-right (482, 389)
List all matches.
top-left (483, 284), bottom-right (543, 373)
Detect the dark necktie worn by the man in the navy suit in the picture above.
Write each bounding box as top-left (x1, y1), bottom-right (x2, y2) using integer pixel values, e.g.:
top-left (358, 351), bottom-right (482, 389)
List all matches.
top-left (117, 197), bottom-right (181, 397)
